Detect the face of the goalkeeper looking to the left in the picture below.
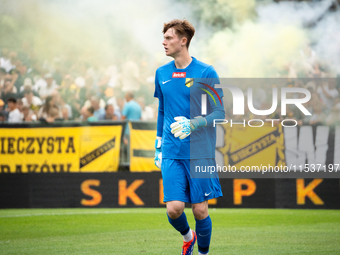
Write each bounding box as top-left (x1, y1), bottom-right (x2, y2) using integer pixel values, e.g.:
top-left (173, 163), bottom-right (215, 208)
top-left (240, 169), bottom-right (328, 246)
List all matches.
top-left (162, 27), bottom-right (185, 57)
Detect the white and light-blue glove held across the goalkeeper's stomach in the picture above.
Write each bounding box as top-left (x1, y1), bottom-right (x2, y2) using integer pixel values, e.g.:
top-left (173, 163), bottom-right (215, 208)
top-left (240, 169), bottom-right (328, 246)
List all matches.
top-left (170, 116), bottom-right (207, 139)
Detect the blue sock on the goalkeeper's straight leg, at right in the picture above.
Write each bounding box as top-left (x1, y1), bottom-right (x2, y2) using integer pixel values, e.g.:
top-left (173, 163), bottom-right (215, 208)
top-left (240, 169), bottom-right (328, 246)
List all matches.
top-left (196, 215), bottom-right (212, 254)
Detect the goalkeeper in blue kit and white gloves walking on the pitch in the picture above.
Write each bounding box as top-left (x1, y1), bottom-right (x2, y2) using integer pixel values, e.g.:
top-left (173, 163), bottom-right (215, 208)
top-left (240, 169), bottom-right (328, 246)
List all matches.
top-left (154, 20), bottom-right (225, 255)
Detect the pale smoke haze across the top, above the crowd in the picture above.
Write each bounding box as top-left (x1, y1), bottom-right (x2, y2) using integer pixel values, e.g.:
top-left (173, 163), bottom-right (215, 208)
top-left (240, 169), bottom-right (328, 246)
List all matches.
top-left (0, 0), bottom-right (340, 77)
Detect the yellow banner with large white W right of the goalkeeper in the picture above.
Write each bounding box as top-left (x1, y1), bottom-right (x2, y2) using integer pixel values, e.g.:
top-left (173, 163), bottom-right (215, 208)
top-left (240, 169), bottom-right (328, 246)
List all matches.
top-left (213, 125), bottom-right (340, 178)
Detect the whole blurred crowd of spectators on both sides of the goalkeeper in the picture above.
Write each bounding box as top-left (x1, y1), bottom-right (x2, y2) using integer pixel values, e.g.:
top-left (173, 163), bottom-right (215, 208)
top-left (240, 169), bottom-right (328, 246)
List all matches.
top-left (0, 45), bottom-right (340, 125)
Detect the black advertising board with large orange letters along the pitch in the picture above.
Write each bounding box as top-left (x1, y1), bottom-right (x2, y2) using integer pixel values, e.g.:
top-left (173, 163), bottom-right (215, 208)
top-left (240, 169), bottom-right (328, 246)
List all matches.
top-left (0, 172), bottom-right (340, 209)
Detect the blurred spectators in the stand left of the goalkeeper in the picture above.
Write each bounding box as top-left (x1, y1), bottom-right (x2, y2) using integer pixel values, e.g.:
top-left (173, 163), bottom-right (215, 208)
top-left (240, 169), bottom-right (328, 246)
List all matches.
top-left (0, 49), bottom-right (157, 123)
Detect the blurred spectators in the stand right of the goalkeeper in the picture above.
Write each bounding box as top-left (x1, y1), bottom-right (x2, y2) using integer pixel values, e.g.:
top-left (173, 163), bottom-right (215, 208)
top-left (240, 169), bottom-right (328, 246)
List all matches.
top-left (224, 45), bottom-right (340, 126)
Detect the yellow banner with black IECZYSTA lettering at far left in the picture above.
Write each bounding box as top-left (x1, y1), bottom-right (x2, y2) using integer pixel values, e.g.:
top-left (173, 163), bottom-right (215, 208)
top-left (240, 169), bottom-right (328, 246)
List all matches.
top-left (0, 125), bottom-right (123, 173)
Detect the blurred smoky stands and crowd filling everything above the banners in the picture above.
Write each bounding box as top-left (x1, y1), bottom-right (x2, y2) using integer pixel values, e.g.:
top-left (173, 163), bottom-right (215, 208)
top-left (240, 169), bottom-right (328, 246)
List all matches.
top-left (0, 0), bottom-right (340, 125)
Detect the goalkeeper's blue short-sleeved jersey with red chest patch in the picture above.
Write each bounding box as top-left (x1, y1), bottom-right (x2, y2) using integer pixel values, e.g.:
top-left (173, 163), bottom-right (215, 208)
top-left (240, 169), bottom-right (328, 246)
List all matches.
top-left (154, 57), bottom-right (224, 159)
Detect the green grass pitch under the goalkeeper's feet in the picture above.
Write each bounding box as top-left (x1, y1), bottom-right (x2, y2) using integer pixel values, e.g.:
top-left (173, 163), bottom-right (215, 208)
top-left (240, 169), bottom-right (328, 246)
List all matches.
top-left (0, 208), bottom-right (340, 255)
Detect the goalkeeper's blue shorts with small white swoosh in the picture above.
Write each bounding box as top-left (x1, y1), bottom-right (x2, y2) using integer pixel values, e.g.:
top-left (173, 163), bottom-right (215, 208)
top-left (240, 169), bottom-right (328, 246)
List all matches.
top-left (161, 158), bottom-right (222, 204)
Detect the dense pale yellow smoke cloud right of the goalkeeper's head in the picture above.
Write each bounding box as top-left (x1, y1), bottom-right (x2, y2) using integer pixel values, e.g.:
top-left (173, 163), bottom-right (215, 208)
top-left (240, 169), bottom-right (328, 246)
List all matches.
top-left (205, 17), bottom-right (306, 78)
